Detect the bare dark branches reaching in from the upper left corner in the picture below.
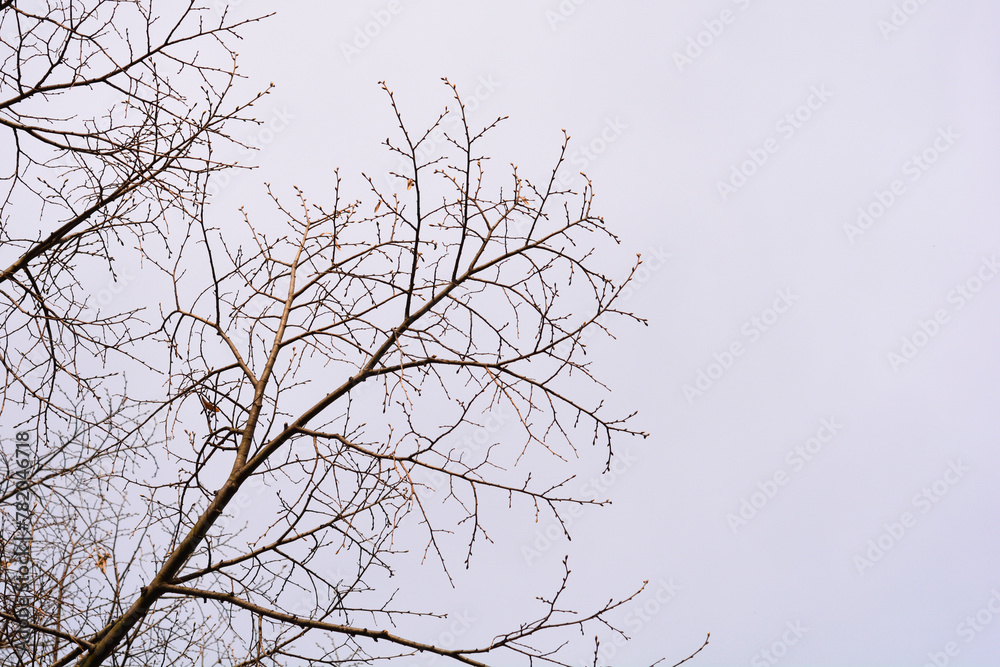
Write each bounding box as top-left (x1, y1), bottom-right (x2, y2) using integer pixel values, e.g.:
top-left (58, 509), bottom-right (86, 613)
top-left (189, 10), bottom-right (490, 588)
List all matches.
top-left (0, 0), bottom-right (266, 426)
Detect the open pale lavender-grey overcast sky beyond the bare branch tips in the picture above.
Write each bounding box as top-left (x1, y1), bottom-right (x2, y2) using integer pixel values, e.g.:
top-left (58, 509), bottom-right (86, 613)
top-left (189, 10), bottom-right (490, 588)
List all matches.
top-left (205, 0), bottom-right (1000, 666)
